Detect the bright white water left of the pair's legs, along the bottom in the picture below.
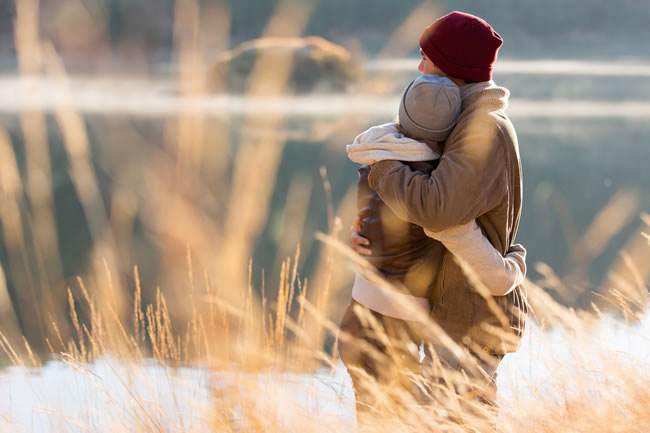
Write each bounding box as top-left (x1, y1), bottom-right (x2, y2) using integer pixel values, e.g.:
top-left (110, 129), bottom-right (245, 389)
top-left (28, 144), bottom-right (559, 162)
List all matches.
top-left (0, 358), bottom-right (354, 433)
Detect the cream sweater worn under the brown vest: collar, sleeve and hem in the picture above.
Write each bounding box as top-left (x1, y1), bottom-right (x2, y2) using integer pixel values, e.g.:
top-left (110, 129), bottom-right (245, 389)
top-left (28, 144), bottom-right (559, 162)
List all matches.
top-left (346, 123), bottom-right (526, 320)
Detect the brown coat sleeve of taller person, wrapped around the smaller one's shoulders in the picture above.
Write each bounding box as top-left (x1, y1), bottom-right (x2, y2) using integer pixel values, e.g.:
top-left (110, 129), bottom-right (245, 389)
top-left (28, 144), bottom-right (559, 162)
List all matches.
top-left (368, 116), bottom-right (508, 232)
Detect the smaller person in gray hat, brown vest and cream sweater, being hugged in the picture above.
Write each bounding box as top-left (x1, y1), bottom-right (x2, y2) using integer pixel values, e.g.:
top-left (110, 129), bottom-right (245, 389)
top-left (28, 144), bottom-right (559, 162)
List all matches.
top-left (341, 75), bottom-right (526, 416)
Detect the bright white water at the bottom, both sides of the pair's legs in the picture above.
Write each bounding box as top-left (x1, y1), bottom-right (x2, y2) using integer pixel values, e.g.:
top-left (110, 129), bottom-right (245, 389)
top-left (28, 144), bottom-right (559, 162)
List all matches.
top-left (0, 315), bottom-right (650, 433)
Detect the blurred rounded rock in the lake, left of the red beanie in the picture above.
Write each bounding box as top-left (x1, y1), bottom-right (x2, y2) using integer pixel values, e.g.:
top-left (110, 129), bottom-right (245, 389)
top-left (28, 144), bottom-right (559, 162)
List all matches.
top-left (207, 37), bottom-right (362, 93)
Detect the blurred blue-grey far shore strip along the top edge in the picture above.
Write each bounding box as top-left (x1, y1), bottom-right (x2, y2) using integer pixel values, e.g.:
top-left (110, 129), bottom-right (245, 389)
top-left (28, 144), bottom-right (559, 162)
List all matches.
top-left (0, 0), bottom-right (650, 63)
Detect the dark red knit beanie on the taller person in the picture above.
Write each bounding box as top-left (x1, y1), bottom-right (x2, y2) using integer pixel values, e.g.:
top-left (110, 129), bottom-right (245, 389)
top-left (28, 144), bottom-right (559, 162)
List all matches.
top-left (420, 11), bottom-right (503, 81)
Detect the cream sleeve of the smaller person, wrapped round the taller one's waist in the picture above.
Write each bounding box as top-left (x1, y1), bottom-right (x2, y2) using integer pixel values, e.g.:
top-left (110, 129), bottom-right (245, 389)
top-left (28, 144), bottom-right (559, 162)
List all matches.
top-left (425, 220), bottom-right (526, 296)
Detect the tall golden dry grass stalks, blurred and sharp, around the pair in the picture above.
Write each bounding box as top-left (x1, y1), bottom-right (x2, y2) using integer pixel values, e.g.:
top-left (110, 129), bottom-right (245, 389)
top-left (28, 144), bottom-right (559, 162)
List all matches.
top-left (0, 0), bottom-right (650, 433)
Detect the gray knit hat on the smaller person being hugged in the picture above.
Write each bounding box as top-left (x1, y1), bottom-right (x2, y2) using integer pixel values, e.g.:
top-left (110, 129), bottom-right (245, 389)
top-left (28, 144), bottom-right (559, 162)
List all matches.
top-left (397, 75), bottom-right (461, 141)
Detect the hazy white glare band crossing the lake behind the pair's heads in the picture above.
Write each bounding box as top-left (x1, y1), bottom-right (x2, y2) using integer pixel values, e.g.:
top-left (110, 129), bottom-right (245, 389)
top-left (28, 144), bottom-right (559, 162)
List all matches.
top-left (0, 74), bottom-right (650, 120)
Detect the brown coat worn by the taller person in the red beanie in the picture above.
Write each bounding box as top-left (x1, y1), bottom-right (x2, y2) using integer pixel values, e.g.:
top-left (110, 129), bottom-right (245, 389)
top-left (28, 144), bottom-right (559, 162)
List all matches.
top-left (368, 88), bottom-right (527, 354)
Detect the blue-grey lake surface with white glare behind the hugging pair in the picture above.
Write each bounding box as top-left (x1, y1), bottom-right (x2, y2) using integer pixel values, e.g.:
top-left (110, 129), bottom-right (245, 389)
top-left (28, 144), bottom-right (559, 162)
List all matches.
top-left (0, 59), bottom-right (650, 318)
